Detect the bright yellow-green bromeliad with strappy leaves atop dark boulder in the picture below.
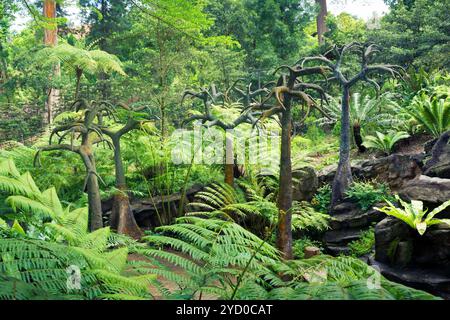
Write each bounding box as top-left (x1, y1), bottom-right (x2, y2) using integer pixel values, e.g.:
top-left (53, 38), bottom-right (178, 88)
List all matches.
top-left (374, 195), bottom-right (450, 235)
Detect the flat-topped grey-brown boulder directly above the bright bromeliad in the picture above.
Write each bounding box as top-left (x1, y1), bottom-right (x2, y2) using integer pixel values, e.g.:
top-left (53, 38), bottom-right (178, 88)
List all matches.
top-left (399, 175), bottom-right (450, 204)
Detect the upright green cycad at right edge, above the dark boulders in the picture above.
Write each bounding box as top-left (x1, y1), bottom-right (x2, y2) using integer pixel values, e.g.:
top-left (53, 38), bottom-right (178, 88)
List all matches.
top-left (408, 92), bottom-right (450, 138)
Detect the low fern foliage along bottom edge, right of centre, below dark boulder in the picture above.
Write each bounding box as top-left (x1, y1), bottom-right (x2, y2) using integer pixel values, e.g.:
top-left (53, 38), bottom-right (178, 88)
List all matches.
top-left (269, 255), bottom-right (437, 300)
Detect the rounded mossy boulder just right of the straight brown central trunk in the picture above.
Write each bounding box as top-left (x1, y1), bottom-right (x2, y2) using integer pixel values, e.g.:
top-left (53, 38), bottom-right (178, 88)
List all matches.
top-left (292, 167), bottom-right (319, 201)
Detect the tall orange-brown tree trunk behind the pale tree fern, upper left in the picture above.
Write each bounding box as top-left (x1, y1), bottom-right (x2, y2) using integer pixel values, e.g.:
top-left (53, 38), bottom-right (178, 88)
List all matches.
top-left (43, 0), bottom-right (61, 124)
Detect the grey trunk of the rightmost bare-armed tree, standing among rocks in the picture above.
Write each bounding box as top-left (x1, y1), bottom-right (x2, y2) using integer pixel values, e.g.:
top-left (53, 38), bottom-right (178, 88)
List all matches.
top-left (330, 86), bottom-right (352, 210)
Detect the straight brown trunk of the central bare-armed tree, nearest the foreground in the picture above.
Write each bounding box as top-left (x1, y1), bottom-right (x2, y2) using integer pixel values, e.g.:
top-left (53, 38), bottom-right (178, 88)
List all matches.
top-left (277, 106), bottom-right (292, 259)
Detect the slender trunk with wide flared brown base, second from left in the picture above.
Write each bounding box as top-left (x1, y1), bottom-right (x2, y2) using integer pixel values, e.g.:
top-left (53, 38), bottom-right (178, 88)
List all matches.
top-left (110, 136), bottom-right (142, 239)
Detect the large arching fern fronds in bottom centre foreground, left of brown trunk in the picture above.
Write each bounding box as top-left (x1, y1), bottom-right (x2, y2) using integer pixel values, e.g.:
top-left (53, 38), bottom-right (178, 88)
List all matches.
top-left (144, 217), bottom-right (279, 299)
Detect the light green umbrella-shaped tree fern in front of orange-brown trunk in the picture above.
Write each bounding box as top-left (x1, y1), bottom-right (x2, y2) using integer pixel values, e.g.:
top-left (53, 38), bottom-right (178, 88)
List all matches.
top-left (37, 42), bottom-right (126, 100)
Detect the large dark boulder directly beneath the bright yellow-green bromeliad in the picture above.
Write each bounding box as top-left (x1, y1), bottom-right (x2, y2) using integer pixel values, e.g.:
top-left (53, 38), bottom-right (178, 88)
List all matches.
top-left (370, 217), bottom-right (450, 299)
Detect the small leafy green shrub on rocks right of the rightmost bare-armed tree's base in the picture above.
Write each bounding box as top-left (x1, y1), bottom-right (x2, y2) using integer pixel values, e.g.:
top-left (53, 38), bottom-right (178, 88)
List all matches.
top-left (345, 182), bottom-right (390, 211)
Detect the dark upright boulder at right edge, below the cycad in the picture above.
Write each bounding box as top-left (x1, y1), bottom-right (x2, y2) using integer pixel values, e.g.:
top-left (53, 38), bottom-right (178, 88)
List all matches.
top-left (423, 131), bottom-right (450, 179)
